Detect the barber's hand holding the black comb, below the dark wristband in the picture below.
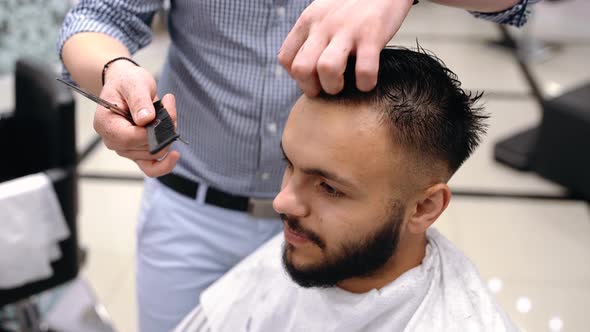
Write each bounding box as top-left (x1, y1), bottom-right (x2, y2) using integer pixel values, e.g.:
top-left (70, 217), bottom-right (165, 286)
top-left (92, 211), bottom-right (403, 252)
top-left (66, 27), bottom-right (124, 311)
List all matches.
top-left (94, 60), bottom-right (180, 177)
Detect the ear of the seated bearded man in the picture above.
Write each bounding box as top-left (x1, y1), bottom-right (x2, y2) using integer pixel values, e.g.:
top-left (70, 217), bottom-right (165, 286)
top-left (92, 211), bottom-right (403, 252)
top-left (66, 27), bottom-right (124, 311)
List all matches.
top-left (407, 183), bottom-right (451, 234)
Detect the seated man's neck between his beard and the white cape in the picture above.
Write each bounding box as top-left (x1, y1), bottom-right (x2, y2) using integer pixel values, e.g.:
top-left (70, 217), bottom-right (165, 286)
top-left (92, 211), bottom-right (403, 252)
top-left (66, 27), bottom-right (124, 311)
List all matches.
top-left (338, 234), bottom-right (426, 294)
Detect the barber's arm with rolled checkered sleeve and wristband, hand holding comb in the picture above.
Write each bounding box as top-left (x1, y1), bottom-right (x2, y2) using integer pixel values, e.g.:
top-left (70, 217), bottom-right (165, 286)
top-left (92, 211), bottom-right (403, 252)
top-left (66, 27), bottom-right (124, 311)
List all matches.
top-left (58, 0), bottom-right (180, 177)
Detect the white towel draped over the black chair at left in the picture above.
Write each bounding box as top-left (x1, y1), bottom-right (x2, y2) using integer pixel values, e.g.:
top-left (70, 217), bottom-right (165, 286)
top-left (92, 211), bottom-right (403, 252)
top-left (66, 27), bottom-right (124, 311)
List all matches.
top-left (0, 173), bottom-right (70, 289)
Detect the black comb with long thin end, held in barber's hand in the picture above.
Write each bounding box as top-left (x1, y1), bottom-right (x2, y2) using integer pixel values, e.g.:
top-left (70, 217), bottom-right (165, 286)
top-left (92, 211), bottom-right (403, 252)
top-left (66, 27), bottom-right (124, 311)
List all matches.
top-left (57, 78), bottom-right (188, 154)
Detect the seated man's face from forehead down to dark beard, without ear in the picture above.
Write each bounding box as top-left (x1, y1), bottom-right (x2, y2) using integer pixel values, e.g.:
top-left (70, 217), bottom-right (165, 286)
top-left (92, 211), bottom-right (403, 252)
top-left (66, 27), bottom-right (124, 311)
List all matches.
top-left (274, 96), bottom-right (414, 287)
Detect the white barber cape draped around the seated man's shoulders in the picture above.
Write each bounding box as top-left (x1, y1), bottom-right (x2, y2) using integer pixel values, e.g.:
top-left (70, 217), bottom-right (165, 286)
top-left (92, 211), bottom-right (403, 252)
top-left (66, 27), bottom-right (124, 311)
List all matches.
top-left (175, 229), bottom-right (517, 332)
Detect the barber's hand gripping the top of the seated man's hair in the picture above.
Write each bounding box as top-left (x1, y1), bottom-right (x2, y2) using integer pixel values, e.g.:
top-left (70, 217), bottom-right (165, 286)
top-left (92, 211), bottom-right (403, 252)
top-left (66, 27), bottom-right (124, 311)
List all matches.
top-left (278, 0), bottom-right (413, 97)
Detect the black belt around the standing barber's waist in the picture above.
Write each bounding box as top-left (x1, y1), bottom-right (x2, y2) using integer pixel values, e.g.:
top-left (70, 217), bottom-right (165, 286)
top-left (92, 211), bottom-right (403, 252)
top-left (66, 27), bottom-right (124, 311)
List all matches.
top-left (158, 173), bottom-right (278, 218)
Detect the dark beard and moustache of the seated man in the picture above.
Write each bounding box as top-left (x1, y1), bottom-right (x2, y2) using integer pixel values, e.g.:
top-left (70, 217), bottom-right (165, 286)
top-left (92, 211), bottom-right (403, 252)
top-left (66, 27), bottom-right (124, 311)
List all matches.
top-left (281, 202), bottom-right (404, 288)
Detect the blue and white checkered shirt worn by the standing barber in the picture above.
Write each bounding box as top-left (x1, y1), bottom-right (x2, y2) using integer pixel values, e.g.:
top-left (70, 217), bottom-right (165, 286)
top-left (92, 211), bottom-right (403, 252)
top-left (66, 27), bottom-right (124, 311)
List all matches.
top-left (58, 0), bottom-right (536, 198)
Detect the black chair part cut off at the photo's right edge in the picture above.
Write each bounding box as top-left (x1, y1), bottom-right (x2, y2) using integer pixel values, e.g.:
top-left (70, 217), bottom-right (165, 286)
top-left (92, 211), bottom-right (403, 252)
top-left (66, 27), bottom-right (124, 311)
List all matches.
top-left (494, 83), bottom-right (590, 201)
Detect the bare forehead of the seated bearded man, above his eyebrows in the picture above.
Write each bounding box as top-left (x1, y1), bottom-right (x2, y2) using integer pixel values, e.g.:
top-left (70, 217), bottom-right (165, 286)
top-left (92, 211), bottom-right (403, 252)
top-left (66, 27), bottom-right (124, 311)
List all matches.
top-left (282, 96), bottom-right (403, 192)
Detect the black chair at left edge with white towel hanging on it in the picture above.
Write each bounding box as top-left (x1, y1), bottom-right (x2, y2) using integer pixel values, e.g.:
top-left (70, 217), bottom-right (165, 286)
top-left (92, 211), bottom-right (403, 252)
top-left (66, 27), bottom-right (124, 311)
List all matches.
top-left (0, 59), bottom-right (80, 331)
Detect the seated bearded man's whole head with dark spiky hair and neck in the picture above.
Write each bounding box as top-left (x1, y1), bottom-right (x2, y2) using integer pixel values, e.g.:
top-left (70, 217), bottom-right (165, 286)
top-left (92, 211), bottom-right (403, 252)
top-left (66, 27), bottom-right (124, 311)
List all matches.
top-left (274, 48), bottom-right (486, 291)
